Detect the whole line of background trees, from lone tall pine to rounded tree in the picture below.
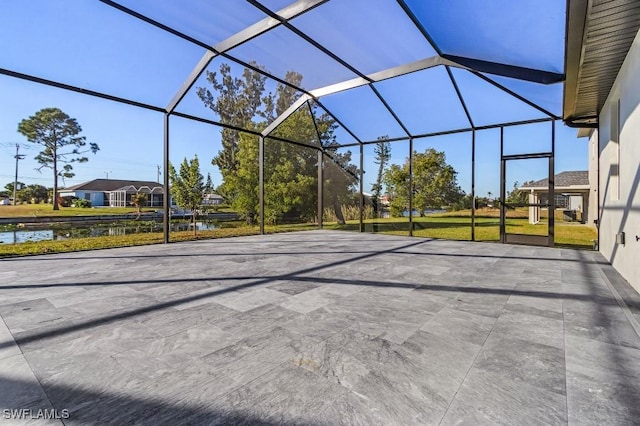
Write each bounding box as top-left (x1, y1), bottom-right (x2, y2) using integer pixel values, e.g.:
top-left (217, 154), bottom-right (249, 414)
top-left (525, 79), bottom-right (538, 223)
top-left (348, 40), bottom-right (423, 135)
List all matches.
top-left (8, 63), bottom-right (465, 224)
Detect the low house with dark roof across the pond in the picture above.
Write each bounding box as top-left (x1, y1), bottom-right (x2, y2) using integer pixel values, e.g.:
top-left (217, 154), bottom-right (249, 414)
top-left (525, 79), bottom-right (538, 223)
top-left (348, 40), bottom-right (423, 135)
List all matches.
top-left (58, 179), bottom-right (164, 207)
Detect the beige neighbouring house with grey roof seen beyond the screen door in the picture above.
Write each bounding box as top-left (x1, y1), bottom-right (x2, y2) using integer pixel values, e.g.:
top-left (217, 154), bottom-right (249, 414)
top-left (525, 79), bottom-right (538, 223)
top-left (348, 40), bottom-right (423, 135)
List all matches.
top-left (518, 170), bottom-right (596, 223)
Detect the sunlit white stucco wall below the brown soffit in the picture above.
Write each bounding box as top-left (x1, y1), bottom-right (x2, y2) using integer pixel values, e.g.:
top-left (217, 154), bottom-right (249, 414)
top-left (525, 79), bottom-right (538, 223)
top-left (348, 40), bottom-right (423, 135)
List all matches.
top-left (599, 27), bottom-right (640, 291)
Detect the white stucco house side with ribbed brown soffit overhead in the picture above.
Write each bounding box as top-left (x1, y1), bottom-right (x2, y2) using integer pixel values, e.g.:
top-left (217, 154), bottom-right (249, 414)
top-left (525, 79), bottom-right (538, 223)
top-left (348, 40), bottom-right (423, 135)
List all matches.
top-left (563, 4), bottom-right (640, 291)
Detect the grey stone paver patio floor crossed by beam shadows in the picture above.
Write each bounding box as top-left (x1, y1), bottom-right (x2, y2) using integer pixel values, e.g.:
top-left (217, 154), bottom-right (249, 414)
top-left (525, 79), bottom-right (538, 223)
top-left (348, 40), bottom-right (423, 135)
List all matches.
top-left (0, 231), bottom-right (640, 425)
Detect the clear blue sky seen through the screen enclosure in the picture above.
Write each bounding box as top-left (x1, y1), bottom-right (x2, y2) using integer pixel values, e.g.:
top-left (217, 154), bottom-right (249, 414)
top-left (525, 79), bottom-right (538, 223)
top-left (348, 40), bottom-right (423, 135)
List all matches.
top-left (0, 0), bottom-right (587, 195)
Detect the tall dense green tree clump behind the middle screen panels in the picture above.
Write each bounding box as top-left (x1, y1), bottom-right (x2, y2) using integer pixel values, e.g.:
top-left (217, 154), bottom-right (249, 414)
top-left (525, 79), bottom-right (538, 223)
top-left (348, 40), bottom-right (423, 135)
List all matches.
top-left (192, 64), bottom-right (359, 223)
